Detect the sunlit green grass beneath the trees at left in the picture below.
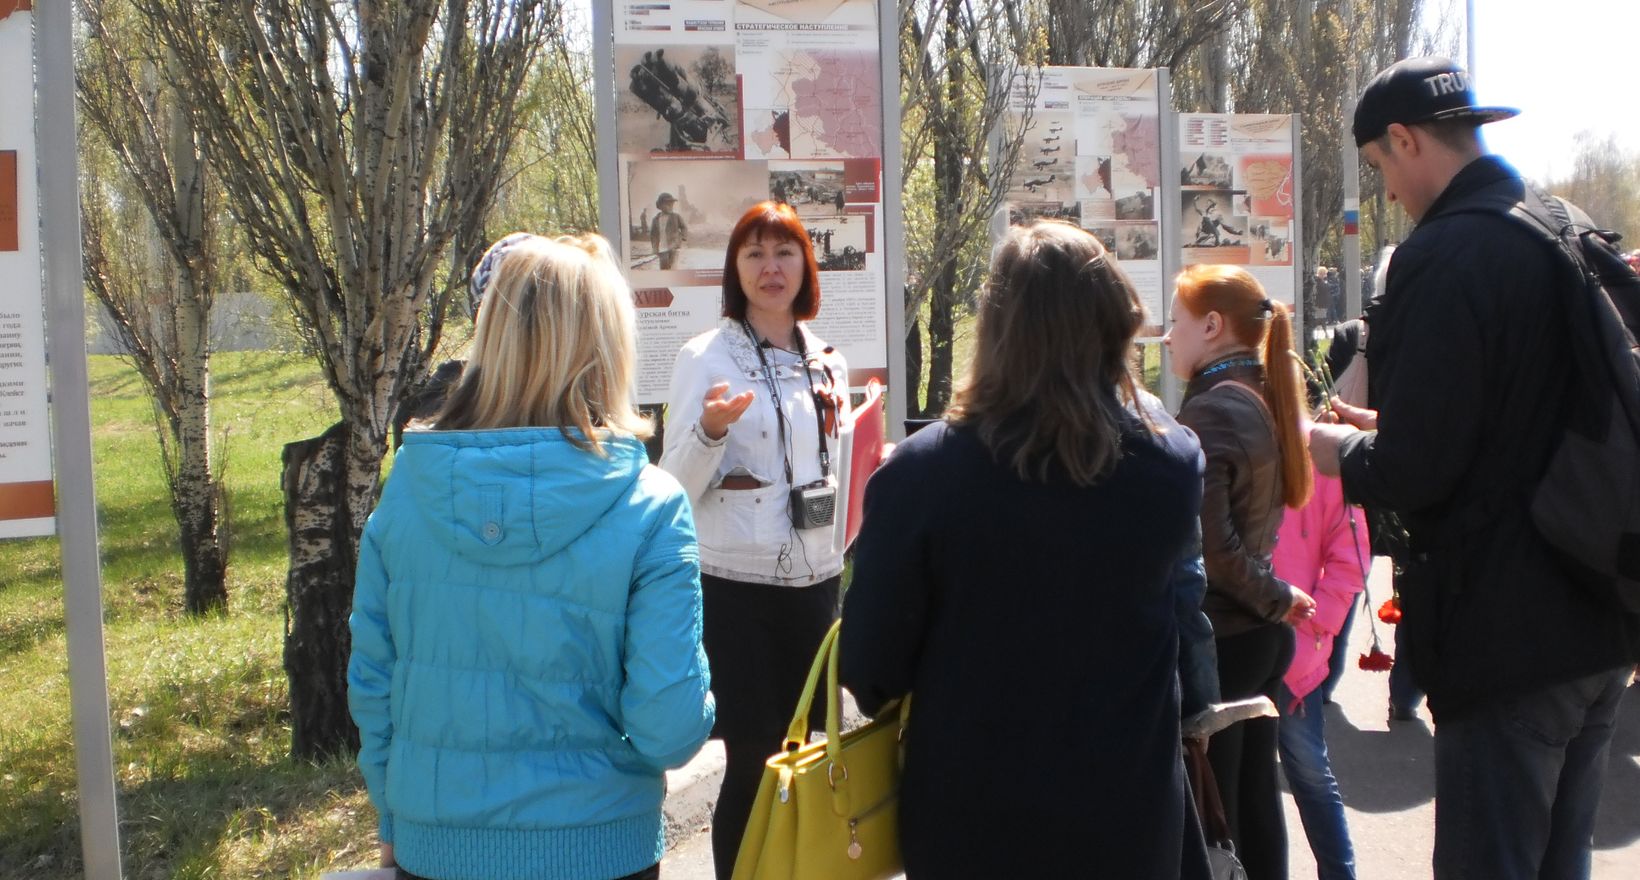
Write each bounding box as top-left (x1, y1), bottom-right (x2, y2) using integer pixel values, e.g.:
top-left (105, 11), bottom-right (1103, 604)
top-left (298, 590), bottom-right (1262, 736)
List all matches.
top-left (0, 352), bottom-right (387, 880)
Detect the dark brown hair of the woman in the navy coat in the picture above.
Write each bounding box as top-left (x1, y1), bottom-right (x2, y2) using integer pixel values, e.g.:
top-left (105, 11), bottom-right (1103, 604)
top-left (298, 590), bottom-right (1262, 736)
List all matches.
top-left (946, 221), bottom-right (1145, 487)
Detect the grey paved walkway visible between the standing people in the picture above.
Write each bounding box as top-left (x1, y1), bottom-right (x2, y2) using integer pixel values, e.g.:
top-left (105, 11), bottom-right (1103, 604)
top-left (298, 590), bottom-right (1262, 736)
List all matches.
top-left (663, 560), bottom-right (1640, 880)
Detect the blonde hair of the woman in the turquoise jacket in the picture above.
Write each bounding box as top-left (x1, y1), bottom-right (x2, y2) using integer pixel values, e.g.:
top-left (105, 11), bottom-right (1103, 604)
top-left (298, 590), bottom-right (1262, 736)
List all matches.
top-left (435, 234), bottom-right (654, 454)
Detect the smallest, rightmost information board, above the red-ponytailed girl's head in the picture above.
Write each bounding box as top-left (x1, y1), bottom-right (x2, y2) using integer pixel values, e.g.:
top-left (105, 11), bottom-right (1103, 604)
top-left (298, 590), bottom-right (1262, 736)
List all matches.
top-left (1178, 113), bottom-right (1299, 306)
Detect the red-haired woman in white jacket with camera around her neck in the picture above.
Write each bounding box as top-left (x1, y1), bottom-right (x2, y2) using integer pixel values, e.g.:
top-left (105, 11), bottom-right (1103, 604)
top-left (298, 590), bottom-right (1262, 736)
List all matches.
top-left (661, 202), bottom-right (851, 878)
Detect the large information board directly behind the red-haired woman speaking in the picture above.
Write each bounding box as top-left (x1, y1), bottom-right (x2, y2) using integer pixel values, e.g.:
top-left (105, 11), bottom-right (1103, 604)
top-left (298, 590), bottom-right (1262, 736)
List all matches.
top-left (595, 0), bottom-right (900, 394)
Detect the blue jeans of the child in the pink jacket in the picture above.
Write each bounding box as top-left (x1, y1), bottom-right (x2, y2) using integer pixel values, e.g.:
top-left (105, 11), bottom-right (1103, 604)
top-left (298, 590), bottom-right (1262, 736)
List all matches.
top-left (1276, 683), bottom-right (1355, 880)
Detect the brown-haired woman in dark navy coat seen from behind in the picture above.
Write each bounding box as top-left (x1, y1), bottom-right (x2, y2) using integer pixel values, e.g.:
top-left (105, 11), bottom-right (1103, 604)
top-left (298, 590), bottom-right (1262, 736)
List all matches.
top-left (840, 221), bottom-right (1207, 880)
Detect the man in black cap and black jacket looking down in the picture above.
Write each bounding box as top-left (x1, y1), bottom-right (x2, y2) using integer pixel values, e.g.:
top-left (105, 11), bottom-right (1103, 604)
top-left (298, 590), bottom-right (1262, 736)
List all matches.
top-left (1310, 57), bottom-right (1640, 880)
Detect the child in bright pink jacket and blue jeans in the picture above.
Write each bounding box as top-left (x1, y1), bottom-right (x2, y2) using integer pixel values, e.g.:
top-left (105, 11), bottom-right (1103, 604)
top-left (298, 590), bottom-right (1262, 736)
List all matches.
top-left (1271, 472), bottom-right (1371, 880)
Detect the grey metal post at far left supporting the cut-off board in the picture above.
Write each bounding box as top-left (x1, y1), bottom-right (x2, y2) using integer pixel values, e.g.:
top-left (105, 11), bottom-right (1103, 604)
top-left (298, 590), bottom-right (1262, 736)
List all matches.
top-left (34, 3), bottom-right (120, 880)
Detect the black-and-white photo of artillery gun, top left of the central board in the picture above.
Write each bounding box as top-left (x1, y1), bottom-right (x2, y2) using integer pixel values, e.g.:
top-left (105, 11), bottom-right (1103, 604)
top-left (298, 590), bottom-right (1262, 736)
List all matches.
top-left (615, 44), bottom-right (740, 156)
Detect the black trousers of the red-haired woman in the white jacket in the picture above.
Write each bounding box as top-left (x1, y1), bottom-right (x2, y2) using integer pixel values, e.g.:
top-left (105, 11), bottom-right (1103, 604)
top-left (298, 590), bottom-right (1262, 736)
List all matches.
top-left (700, 574), bottom-right (841, 880)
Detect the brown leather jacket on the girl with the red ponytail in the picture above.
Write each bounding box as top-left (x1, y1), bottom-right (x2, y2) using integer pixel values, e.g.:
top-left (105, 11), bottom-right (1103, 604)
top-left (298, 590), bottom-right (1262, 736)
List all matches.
top-left (1179, 352), bottom-right (1292, 637)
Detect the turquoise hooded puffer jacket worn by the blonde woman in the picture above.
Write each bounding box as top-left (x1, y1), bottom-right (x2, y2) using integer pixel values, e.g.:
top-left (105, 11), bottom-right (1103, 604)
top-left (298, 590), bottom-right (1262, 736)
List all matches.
top-left (348, 428), bottom-right (713, 880)
